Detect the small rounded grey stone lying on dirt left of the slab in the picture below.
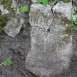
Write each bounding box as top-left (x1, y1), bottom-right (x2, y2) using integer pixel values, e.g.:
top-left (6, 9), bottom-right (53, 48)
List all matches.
top-left (4, 18), bottom-right (24, 37)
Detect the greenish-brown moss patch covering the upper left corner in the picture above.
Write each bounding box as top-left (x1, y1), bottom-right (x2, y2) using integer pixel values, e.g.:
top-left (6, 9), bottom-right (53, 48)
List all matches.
top-left (0, 0), bottom-right (16, 33)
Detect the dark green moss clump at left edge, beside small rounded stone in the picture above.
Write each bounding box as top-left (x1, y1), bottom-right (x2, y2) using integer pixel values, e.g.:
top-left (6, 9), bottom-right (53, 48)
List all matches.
top-left (0, 10), bottom-right (8, 33)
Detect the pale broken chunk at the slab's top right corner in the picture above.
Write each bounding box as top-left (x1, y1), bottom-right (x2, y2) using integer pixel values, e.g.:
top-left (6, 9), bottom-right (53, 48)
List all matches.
top-left (53, 1), bottom-right (72, 19)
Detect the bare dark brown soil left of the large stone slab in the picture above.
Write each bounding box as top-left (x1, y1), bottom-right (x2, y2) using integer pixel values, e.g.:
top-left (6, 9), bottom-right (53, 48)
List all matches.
top-left (0, 26), bottom-right (36, 77)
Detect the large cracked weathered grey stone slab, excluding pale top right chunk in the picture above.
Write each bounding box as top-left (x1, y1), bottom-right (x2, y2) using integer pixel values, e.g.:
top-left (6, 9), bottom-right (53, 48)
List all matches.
top-left (26, 1), bottom-right (72, 77)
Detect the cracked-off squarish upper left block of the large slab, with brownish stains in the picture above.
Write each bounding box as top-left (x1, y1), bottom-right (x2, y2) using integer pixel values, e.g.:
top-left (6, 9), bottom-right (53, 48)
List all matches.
top-left (29, 4), bottom-right (53, 30)
